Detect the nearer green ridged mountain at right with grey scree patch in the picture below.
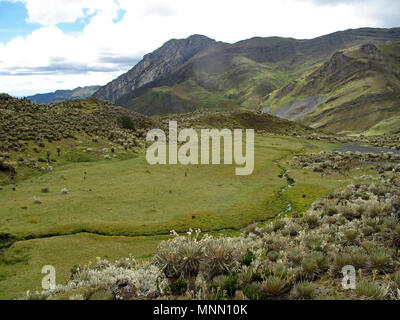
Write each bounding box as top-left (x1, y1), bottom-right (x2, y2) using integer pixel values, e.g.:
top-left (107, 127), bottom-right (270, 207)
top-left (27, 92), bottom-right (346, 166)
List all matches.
top-left (263, 43), bottom-right (400, 133)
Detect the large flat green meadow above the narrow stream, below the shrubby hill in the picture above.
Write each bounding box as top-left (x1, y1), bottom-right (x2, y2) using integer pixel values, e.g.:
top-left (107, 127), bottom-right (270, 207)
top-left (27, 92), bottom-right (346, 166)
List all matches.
top-left (0, 138), bottom-right (308, 238)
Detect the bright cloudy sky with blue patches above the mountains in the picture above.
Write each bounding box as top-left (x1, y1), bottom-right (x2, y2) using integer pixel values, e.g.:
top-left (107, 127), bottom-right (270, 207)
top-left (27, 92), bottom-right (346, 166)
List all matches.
top-left (0, 0), bottom-right (400, 96)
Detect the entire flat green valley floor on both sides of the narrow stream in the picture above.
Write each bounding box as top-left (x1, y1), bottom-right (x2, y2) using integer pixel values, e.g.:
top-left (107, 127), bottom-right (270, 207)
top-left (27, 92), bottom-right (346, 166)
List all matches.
top-left (0, 136), bottom-right (372, 299)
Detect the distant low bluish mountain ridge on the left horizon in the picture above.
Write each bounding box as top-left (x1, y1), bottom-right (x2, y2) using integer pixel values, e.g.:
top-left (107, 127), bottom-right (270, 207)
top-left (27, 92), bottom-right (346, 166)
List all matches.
top-left (27, 86), bottom-right (100, 103)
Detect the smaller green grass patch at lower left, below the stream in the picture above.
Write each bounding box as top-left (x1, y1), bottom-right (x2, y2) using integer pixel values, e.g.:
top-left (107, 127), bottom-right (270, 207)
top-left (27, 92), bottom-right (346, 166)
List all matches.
top-left (0, 233), bottom-right (167, 300)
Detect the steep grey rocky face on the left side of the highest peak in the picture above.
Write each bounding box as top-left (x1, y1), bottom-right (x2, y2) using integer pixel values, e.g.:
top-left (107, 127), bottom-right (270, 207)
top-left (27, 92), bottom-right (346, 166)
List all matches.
top-left (94, 35), bottom-right (215, 103)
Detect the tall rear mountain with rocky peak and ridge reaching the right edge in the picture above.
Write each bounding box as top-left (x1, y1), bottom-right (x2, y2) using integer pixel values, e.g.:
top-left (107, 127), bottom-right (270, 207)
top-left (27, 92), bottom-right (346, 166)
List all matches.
top-left (95, 28), bottom-right (400, 127)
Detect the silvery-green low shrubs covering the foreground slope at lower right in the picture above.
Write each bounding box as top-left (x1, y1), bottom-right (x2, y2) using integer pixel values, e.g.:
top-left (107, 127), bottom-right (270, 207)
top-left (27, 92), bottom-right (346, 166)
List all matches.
top-left (20, 168), bottom-right (400, 300)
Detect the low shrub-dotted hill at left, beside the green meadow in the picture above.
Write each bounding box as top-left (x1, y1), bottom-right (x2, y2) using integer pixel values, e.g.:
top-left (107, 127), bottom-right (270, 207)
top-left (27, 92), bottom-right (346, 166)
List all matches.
top-left (0, 94), bottom-right (159, 184)
